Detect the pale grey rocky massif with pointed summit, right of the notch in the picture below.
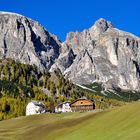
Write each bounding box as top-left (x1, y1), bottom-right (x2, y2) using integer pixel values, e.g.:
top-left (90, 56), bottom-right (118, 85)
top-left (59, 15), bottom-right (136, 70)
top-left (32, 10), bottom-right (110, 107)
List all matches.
top-left (56, 19), bottom-right (140, 90)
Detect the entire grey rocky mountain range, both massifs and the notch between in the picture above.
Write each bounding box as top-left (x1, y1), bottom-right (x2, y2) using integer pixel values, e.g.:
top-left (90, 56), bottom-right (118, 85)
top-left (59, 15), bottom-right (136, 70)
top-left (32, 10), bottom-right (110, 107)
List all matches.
top-left (0, 12), bottom-right (140, 90)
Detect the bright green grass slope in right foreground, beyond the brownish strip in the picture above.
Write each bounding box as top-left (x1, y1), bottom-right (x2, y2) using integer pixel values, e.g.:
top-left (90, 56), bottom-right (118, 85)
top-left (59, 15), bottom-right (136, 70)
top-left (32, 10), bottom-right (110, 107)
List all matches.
top-left (59, 103), bottom-right (140, 140)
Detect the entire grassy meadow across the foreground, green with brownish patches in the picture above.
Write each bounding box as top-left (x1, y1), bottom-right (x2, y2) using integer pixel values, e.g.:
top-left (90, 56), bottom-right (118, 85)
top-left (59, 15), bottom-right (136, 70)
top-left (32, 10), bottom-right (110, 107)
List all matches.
top-left (0, 102), bottom-right (140, 140)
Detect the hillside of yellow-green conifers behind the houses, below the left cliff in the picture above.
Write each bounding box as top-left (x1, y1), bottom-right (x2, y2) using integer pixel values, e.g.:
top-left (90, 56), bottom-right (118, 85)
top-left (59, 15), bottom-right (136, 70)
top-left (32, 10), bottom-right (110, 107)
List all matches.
top-left (0, 59), bottom-right (124, 120)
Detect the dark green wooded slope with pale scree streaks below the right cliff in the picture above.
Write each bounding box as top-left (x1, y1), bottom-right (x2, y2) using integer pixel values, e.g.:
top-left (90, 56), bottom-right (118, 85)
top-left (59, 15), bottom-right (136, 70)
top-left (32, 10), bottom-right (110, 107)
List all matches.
top-left (77, 82), bottom-right (140, 102)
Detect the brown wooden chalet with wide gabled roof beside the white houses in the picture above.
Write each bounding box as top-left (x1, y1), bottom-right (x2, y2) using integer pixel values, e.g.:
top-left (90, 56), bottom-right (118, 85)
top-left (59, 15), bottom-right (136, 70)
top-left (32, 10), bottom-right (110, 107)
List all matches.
top-left (70, 98), bottom-right (95, 112)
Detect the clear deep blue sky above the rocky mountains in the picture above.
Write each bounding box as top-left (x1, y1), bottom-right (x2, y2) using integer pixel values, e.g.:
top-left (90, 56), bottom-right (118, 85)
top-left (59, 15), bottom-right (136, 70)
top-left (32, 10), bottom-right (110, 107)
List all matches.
top-left (0, 0), bottom-right (140, 41)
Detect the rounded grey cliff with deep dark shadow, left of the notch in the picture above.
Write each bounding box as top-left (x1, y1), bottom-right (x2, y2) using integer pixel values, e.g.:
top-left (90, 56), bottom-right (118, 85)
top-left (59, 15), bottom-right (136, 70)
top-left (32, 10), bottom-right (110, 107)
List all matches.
top-left (0, 12), bottom-right (61, 69)
